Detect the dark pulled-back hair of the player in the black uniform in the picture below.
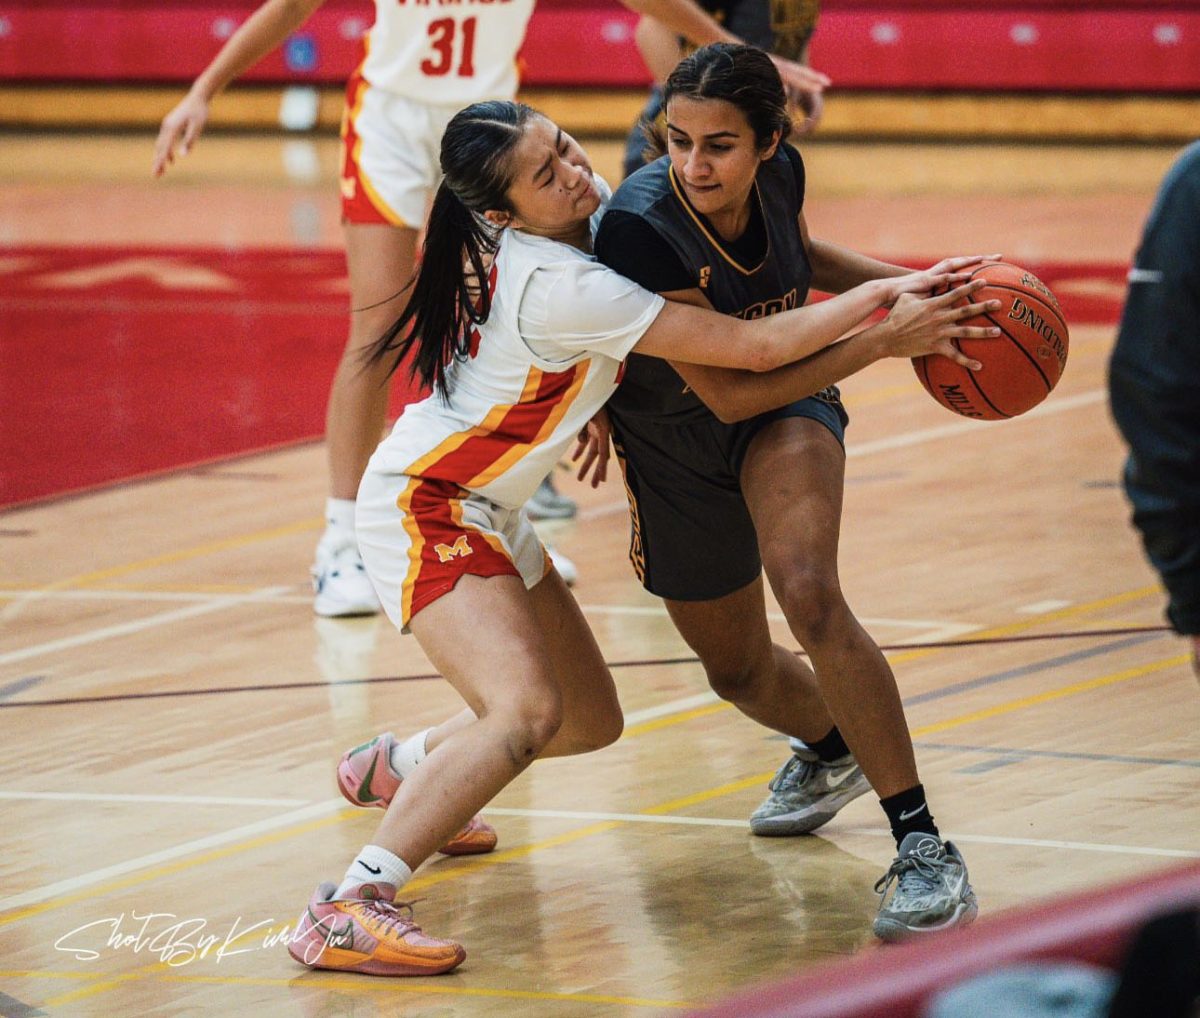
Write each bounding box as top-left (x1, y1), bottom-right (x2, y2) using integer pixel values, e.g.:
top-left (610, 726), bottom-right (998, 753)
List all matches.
top-left (642, 42), bottom-right (792, 155)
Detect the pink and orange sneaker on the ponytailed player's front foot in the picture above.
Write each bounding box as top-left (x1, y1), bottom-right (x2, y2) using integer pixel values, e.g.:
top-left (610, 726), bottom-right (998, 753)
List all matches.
top-left (288, 884), bottom-right (467, 976)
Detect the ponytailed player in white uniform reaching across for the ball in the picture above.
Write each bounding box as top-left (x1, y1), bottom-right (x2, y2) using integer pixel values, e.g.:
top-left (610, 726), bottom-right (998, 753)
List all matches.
top-left (280, 101), bottom-right (992, 976)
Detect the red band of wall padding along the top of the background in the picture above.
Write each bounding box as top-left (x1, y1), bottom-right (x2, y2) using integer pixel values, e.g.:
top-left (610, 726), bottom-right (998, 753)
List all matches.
top-left (0, 0), bottom-right (1200, 91)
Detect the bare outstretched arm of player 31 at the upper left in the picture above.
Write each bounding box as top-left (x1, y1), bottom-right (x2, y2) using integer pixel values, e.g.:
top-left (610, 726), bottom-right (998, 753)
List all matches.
top-left (152, 0), bottom-right (325, 176)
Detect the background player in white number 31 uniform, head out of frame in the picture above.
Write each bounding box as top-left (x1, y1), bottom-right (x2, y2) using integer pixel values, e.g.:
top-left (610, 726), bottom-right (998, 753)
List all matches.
top-left (154, 0), bottom-right (821, 616)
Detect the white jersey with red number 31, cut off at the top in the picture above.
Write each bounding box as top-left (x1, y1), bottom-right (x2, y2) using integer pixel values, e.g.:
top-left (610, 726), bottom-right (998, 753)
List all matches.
top-left (362, 0), bottom-right (534, 107)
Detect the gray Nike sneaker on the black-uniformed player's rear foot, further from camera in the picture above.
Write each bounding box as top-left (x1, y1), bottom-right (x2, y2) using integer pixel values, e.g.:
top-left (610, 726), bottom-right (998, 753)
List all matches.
top-left (750, 741), bottom-right (871, 838)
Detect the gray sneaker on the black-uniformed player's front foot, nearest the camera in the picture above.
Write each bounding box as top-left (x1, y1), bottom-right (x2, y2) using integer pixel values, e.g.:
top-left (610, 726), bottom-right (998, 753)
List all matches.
top-left (875, 831), bottom-right (979, 941)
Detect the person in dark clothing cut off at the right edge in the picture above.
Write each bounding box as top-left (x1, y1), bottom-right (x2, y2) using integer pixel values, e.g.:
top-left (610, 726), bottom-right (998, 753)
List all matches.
top-left (1109, 142), bottom-right (1200, 678)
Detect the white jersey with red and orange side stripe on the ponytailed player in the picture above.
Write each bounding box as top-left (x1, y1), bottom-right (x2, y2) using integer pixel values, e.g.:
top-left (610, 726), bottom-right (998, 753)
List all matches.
top-left (367, 180), bottom-right (664, 509)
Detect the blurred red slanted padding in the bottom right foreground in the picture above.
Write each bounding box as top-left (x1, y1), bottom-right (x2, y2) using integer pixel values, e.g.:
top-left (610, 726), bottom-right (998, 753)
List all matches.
top-left (692, 862), bottom-right (1200, 1018)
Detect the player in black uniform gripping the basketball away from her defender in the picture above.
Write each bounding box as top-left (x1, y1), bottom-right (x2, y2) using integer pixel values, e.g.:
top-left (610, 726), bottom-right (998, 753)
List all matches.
top-left (589, 43), bottom-right (977, 940)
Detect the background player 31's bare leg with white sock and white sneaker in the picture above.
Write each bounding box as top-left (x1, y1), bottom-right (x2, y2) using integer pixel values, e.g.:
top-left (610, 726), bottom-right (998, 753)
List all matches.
top-left (313, 223), bottom-right (416, 616)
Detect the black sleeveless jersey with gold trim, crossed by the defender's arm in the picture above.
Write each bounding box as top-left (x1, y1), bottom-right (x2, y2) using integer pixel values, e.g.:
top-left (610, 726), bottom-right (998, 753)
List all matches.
top-left (596, 145), bottom-right (812, 420)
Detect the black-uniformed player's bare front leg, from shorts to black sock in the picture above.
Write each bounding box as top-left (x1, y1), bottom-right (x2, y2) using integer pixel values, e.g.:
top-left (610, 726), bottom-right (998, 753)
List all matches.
top-left (742, 418), bottom-right (917, 798)
